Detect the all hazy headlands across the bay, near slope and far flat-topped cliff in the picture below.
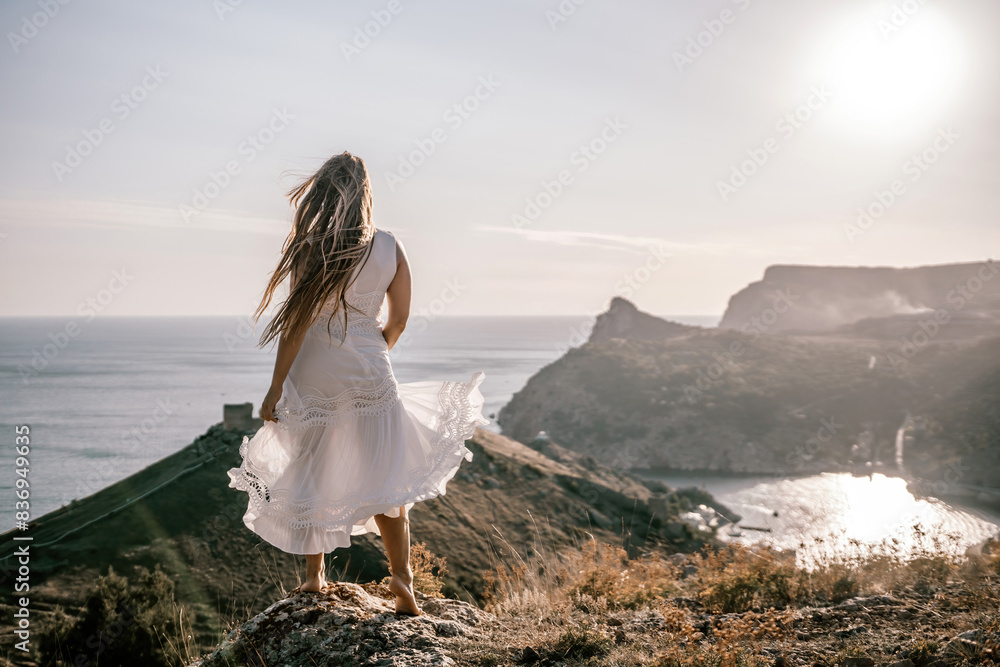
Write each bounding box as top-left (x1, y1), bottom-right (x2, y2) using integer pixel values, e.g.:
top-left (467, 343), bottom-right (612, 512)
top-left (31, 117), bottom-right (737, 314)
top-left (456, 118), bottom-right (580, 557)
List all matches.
top-left (498, 260), bottom-right (1000, 500)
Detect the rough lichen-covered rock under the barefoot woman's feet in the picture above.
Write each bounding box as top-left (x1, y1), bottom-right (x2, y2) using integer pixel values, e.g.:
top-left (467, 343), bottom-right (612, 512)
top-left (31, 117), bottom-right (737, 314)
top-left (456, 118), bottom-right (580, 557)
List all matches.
top-left (189, 581), bottom-right (493, 667)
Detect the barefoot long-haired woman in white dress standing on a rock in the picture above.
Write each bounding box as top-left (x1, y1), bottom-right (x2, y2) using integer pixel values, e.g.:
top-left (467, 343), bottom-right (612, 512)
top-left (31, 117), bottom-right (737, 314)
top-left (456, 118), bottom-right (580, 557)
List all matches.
top-left (228, 152), bottom-right (489, 615)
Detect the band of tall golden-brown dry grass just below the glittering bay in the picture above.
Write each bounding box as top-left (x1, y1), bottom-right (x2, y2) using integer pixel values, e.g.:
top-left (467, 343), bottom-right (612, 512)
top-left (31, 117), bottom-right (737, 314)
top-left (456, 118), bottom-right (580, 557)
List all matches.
top-left (483, 528), bottom-right (1000, 613)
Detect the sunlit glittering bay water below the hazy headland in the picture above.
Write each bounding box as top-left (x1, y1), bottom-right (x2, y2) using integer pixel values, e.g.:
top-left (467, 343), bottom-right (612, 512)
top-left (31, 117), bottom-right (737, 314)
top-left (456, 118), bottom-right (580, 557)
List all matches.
top-left (659, 473), bottom-right (1000, 567)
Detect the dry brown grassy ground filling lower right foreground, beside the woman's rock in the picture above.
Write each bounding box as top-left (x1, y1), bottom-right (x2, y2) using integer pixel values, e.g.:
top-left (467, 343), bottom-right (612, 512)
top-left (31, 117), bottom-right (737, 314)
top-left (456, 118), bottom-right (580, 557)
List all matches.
top-left (456, 534), bottom-right (1000, 667)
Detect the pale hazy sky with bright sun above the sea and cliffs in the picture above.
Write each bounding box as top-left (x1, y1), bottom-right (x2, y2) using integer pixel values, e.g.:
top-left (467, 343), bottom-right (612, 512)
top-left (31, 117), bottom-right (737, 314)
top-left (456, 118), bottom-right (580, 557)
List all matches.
top-left (0, 0), bottom-right (1000, 316)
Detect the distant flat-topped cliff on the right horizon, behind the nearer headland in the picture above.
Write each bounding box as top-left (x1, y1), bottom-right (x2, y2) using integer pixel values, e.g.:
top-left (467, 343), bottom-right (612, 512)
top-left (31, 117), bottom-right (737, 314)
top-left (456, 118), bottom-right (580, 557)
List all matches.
top-left (719, 260), bottom-right (1000, 333)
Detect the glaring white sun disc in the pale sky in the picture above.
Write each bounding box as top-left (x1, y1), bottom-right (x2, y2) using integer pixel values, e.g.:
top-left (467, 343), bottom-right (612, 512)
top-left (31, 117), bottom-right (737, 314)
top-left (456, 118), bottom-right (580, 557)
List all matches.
top-left (826, 6), bottom-right (964, 130)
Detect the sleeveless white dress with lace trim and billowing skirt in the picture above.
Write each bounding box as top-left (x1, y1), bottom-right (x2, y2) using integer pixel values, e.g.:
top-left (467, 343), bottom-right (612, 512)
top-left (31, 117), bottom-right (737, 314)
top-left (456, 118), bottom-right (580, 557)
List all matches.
top-left (228, 230), bottom-right (489, 554)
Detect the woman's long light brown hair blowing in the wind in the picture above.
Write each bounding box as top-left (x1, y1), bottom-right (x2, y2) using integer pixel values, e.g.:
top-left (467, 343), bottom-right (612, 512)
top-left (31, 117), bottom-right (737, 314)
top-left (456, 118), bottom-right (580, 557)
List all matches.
top-left (254, 151), bottom-right (375, 347)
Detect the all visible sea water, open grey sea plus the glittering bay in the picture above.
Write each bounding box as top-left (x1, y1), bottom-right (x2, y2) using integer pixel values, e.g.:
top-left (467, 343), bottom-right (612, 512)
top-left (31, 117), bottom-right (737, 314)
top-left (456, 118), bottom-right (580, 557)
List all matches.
top-left (0, 315), bottom-right (1000, 550)
